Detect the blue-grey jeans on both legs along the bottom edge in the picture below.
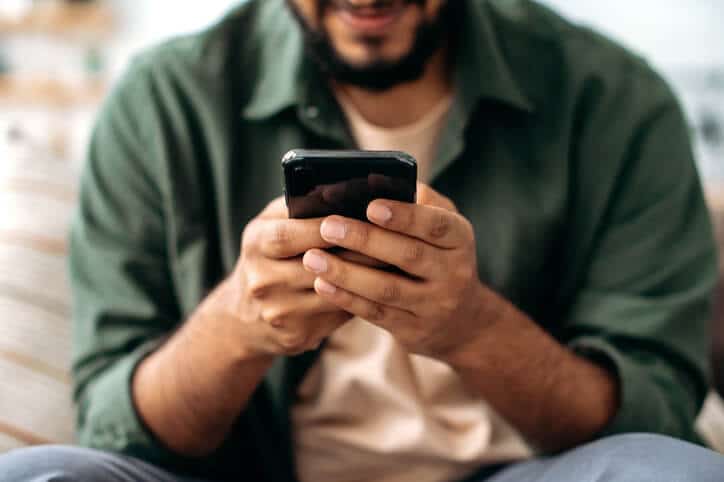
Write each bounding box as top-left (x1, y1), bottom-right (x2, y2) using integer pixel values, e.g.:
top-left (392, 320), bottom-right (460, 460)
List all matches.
top-left (0, 434), bottom-right (724, 482)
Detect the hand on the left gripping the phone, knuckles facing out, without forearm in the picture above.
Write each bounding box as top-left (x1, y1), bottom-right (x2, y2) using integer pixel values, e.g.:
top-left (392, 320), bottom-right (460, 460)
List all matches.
top-left (208, 198), bottom-right (352, 357)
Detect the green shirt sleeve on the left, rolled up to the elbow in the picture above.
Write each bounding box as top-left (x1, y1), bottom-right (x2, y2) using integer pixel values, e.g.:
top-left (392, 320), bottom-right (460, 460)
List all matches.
top-left (70, 56), bottom-right (192, 465)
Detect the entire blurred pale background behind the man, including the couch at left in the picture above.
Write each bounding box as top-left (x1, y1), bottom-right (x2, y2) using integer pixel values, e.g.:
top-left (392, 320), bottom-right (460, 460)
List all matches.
top-left (0, 0), bottom-right (724, 452)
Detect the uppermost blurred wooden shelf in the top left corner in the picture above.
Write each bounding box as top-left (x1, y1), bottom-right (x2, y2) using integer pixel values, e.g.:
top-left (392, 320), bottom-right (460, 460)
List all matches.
top-left (0, 1), bottom-right (114, 39)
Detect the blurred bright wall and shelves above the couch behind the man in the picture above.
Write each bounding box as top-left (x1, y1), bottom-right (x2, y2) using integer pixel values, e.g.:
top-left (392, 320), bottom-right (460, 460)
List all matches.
top-left (0, 0), bottom-right (724, 179)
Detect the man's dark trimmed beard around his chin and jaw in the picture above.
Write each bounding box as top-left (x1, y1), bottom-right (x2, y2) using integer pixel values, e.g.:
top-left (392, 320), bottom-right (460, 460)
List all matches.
top-left (287, 0), bottom-right (463, 92)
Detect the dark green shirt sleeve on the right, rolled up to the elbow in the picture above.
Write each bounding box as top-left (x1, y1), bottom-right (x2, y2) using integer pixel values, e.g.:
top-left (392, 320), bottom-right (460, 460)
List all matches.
top-left (564, 68), bottom-right (717, 441)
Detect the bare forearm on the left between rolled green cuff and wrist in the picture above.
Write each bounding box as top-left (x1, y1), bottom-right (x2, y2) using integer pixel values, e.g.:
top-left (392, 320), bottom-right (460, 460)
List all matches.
top-left (132, 306), bottom-right (273, 457)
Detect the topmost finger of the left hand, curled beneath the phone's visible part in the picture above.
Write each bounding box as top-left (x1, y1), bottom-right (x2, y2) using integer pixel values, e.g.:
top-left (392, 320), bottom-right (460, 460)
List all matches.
top-left (255, 218), bottom-right (332, 259)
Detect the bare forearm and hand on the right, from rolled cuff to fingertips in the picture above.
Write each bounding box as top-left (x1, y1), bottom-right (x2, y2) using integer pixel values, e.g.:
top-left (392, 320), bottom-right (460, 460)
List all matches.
top-left (304, 186), bottom-right (619, 452)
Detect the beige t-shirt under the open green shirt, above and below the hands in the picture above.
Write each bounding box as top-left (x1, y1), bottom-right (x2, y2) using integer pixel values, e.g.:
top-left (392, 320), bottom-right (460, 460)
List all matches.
top-left (292, 88), bottom-right (532, 482)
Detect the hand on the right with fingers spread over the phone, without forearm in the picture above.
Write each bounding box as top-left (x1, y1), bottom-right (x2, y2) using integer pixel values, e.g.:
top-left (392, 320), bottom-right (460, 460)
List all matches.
top-left (304, 185), bottom-right (492, 357)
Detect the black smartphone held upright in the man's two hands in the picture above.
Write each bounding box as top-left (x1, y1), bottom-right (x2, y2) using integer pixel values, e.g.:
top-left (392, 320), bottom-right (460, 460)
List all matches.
top-left (282, 149), bottom-right (417, 221)
